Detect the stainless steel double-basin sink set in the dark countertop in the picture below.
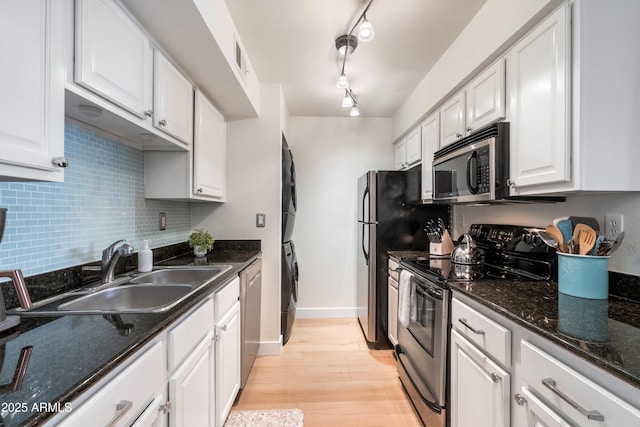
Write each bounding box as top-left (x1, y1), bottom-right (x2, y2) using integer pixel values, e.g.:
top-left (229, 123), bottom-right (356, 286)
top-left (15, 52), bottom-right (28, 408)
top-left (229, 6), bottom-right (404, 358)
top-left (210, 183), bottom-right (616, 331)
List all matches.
top-left (13, 264), bottom-right (231, 316)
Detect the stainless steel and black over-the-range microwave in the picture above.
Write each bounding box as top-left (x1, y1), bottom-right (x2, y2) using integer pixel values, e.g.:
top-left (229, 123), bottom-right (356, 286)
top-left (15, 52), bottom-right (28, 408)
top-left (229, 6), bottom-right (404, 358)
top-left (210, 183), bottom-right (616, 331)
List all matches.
top-left (433, 122), bottom-right (565, 203)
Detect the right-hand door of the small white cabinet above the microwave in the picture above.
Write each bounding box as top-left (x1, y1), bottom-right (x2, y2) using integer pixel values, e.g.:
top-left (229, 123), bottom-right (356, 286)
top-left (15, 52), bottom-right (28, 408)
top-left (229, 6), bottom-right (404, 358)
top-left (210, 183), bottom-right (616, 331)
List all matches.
top-left (465, 58), bottom-right (505, 134)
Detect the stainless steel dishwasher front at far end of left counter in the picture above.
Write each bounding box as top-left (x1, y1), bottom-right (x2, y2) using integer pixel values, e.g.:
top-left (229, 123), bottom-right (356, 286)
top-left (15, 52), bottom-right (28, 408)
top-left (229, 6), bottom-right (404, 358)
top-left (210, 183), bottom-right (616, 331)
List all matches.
top-left (240, 258), bottom-right (262, 388)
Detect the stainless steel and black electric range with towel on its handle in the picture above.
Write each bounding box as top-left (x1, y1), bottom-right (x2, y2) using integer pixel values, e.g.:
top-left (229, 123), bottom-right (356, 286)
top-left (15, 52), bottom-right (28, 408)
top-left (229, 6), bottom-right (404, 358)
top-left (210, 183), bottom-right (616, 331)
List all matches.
top-left (395, 224), bottom-right (555, 426)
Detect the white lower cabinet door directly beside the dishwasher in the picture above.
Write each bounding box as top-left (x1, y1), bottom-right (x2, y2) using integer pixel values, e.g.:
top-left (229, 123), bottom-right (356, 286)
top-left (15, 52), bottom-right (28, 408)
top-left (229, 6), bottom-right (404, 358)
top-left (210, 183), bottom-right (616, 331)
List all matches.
top-left (215, 301), bottom-right (241, 427)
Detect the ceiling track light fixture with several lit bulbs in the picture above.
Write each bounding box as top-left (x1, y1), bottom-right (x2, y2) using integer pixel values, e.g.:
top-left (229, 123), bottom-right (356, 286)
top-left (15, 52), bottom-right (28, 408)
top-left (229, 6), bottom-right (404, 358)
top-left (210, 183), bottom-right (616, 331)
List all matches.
top-left (336, 0), bottom-right (374, 117)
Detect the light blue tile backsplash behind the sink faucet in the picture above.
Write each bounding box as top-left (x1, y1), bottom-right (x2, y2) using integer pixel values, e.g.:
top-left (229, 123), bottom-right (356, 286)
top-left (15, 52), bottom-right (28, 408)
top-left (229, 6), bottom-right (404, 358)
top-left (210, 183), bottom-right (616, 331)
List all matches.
top-left (0, 122), bottom-right (191, 276)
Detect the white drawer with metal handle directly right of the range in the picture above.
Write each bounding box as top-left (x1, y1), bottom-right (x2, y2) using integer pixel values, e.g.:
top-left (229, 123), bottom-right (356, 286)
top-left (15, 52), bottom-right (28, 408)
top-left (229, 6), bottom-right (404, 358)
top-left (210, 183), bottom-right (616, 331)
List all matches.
top-left (451, 298), bottom-right (511, 366)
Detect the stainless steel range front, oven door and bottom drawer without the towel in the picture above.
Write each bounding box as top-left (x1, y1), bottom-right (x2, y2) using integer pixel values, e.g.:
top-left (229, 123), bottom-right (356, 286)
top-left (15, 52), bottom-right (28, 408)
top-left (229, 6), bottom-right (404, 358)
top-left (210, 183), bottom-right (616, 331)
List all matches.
top-left (396, 276), bottom-right (449, 425)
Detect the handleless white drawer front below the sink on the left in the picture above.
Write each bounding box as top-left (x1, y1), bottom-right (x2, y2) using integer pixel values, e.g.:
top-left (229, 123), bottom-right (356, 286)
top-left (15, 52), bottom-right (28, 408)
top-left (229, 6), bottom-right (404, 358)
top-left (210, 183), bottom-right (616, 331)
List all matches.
top-left (168, 298), bottom-right (213, 372)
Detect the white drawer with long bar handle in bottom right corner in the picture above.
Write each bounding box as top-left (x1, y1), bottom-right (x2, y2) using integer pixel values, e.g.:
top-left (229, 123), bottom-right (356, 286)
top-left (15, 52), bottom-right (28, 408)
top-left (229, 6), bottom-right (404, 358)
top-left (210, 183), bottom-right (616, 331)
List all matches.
top-left (521, 341), bottom-right (640, 427)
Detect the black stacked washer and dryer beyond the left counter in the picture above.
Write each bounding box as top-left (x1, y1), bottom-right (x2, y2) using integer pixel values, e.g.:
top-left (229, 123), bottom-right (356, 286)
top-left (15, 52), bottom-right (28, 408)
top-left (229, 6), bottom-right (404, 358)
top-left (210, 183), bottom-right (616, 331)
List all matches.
top-left (280, 135), bottom-right (298, 344)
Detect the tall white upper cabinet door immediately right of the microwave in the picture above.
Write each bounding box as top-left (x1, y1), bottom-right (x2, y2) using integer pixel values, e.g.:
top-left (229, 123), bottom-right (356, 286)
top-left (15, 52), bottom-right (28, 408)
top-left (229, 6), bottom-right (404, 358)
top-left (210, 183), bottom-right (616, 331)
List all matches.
top-left (507, 5), bottom-right (571, 191)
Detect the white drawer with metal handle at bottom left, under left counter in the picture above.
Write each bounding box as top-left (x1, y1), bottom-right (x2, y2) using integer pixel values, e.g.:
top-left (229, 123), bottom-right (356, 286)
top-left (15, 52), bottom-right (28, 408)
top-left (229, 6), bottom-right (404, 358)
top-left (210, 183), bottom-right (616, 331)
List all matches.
top-left (60, 342), bottom-right (165, 426)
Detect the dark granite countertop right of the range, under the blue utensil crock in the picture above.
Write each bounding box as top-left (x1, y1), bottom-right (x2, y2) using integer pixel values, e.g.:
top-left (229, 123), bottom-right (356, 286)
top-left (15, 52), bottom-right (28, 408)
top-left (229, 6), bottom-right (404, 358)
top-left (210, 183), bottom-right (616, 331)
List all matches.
top-left (450, 280), bottom-right (640, 387)
